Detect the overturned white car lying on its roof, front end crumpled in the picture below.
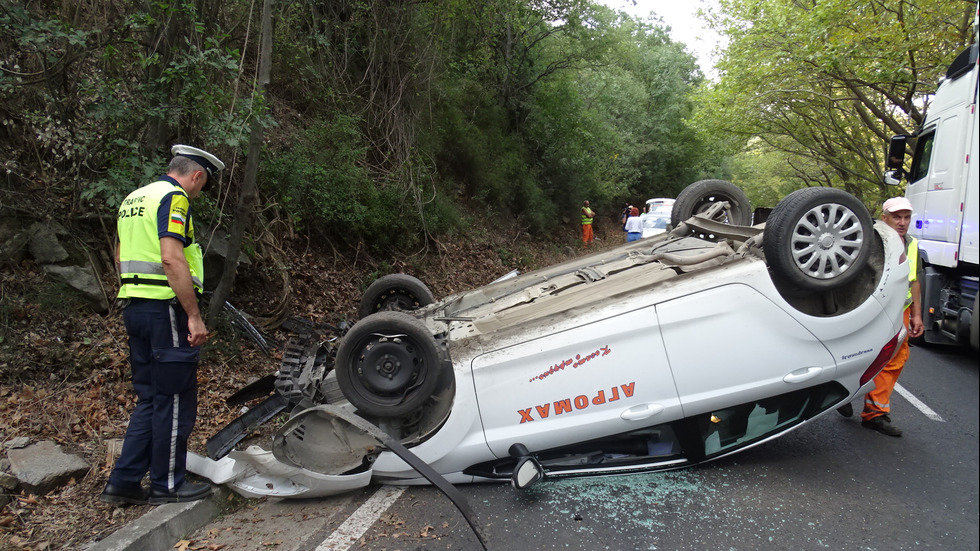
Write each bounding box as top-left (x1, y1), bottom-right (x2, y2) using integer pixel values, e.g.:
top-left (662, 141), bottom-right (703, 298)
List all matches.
top-left (188, 180), bottom-right (908, 504)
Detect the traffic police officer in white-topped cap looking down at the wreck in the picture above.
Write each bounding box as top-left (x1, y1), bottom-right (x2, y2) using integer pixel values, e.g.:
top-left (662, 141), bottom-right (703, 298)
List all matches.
top-left (99, 145), bottom-right (225, 505)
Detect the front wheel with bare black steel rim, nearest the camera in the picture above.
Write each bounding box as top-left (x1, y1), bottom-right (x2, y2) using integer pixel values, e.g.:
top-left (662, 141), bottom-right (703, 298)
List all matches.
top-left (334, 312), bottom-right (441, 417)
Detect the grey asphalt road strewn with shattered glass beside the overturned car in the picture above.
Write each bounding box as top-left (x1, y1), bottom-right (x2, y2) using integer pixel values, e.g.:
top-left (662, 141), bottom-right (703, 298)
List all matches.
top-left (190, 348), bottom-right (980, 551)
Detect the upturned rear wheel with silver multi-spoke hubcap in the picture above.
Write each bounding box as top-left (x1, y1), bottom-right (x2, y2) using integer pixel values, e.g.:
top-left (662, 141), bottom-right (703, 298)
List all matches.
top-left (762, 187), bottom-right (875, 291)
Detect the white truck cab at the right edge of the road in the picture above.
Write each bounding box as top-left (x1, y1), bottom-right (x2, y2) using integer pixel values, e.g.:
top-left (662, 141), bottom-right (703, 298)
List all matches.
top-left (885, 41), bottom-right (980, 350)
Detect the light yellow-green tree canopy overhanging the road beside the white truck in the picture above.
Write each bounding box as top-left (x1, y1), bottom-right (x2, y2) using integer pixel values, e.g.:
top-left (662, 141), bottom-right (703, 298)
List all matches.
top-left (698, 0), bottom-right (976, 202)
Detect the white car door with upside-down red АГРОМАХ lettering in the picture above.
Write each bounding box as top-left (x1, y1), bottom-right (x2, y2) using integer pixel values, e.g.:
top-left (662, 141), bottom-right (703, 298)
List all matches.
top-left (472, 305), bottom-right (681, 457)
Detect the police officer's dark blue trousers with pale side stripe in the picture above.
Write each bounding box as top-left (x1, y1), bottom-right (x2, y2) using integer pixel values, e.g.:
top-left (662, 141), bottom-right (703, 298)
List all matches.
top-left (109, 299), bottom-right (200, 491)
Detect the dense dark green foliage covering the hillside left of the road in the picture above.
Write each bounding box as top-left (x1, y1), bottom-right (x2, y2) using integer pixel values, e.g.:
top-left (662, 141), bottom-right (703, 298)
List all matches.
top-left (0, 0), bottom-right (752, 252)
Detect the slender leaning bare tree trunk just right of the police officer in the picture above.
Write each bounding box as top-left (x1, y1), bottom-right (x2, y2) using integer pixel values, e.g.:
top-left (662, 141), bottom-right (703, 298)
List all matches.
top-left (208, 0), bottom-right (273, 324)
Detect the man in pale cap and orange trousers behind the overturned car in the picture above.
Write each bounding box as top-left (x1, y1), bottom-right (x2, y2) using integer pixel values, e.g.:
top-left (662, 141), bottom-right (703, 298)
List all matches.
top-left (838, 197), bottom-right (925, 436)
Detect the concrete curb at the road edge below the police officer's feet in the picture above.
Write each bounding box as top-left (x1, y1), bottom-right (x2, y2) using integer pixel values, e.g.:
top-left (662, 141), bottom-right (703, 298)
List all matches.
top-left (83, 486), bottom-right (228, 551)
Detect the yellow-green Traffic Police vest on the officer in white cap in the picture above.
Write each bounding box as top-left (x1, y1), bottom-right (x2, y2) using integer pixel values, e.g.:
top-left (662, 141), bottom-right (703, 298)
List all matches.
top-left (116, 180), bottom-right (204, 300)
